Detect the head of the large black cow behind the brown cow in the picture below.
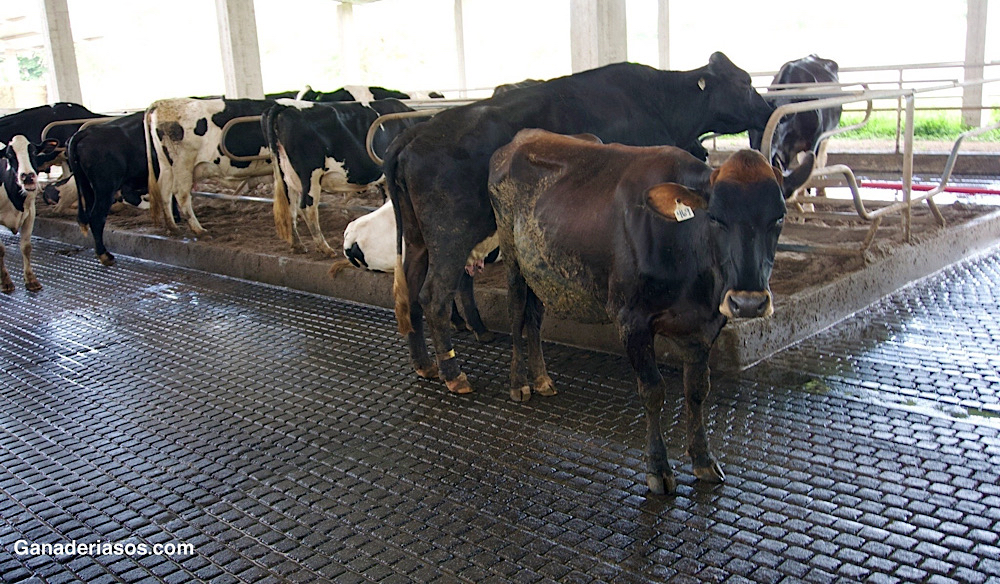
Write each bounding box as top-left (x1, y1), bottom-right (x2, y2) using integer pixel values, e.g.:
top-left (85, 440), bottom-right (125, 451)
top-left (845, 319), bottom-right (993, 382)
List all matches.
top-left (697, 53), bottom-right (774, 134)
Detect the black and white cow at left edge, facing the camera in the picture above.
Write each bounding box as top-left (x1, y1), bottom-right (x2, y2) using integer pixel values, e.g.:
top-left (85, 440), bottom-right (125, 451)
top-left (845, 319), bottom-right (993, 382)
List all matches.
top-left (0, 135), bottom-right (58, 294)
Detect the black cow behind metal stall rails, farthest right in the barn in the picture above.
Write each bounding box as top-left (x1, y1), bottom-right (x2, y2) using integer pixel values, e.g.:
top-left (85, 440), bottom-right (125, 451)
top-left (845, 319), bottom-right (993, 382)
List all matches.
top-left (750, 55), bottom-right (844, 168)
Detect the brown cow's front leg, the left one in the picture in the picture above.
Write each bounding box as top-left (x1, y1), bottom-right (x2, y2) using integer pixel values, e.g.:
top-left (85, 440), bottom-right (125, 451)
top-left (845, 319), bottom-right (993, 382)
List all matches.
top-left (618, 323), bottom-right (677, 495)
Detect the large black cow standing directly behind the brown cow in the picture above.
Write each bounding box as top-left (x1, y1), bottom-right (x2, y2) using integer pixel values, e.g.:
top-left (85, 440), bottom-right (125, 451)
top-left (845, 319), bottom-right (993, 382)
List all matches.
top-left (385, 53), bottom-right (773, 392)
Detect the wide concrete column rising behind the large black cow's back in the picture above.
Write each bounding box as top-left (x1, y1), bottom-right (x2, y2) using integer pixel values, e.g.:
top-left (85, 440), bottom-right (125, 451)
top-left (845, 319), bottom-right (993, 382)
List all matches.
top-left (570, 0), bottom-right (628, 73)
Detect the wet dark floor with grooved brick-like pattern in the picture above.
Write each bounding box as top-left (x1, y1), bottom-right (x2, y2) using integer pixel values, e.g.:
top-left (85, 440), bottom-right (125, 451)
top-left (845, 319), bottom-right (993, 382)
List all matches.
top-left (0, 233), bottom-right (1000, 583)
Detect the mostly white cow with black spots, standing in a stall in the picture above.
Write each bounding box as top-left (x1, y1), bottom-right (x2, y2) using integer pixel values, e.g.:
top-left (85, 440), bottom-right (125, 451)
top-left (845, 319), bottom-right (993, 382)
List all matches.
top-left (144, 98), bottom-right (275, 235)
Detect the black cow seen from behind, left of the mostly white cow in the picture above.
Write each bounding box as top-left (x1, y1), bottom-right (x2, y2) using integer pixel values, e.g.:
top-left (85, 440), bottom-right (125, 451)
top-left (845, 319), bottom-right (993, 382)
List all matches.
top-left (66, 112), bottom-right (149, 266)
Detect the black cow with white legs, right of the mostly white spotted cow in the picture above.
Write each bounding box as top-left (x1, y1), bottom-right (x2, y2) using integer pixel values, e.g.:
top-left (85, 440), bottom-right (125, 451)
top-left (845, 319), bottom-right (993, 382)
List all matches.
top-left (261, 99), bottom-right (425, 256)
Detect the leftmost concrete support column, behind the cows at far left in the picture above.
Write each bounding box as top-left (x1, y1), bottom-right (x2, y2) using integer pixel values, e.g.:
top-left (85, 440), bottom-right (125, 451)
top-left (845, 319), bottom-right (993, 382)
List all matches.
top-left (41, 0), bottom-right (83, 103)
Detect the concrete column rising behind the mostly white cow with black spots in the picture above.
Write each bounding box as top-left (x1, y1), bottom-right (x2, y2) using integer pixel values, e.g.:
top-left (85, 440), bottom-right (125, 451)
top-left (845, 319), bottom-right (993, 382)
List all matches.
top-left (215, 0), bottom-right (264, 99)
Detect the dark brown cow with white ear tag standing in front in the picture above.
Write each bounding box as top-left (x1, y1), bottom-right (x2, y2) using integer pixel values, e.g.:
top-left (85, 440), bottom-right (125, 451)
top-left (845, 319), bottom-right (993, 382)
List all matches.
top-left (489, 130), bottom-right (812, 494)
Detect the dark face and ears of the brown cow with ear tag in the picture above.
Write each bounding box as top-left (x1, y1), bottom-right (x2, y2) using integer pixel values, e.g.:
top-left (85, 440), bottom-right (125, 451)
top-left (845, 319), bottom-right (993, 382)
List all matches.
top-left (647, 150), bottom-right (814, 318)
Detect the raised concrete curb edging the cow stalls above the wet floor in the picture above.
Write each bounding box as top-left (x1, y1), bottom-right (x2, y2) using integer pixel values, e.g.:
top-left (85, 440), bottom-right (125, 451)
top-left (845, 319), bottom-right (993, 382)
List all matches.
top-left (29, 212), bottom-right (1000, 370)
